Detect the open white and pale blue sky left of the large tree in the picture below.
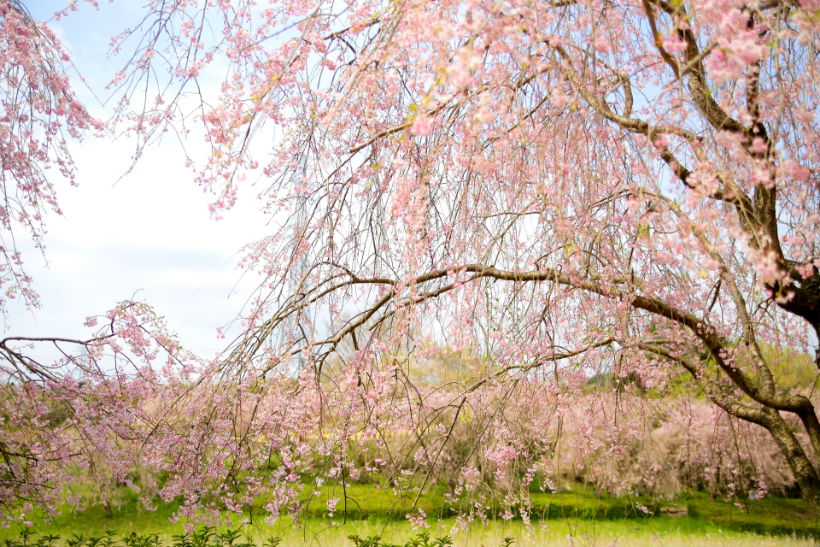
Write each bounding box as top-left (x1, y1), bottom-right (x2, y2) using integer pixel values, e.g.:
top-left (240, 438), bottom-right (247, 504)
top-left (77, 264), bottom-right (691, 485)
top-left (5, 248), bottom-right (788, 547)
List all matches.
top-left (3, 0), bottom-right (267, 357)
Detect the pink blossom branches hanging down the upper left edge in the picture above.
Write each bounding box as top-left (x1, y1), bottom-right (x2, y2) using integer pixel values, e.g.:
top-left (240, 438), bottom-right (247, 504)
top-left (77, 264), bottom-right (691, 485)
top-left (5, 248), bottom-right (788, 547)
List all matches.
top-left (0, 0), bottom-right (102, 311)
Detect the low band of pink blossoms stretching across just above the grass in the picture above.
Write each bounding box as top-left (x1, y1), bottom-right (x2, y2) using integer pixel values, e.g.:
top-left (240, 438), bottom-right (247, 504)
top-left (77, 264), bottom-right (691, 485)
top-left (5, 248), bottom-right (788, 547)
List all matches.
top-left (0, 332), bottom-right (808, 527)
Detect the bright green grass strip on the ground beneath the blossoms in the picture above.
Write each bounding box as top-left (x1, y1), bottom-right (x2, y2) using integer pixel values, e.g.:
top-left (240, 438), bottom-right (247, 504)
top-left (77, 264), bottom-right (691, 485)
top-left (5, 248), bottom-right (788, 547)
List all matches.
top-left (0, 484), bottom-right (820, 547)
